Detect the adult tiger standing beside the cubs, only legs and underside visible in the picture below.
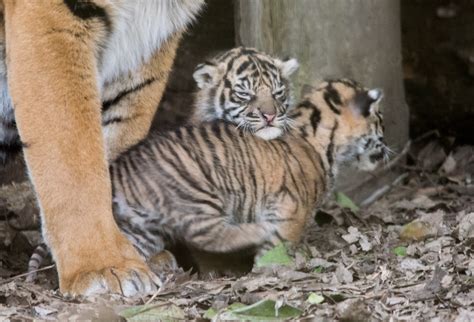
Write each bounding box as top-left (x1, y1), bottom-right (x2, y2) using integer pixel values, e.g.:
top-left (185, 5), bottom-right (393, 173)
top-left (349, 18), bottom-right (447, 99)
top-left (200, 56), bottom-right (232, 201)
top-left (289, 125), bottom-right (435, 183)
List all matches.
top-left (0, 0), bottom-right (204, 295)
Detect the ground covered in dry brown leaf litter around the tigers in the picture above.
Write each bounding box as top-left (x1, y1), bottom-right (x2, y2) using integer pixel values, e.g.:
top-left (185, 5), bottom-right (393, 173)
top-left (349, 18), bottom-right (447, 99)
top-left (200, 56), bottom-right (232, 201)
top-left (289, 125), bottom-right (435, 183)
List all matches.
top-left (0, 133), bottom-right (474, 321)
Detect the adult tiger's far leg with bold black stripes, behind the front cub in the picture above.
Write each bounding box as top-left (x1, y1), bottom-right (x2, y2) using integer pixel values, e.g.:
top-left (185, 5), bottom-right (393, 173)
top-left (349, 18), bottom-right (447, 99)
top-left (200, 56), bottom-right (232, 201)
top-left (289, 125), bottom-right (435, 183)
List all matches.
top-left (102, 32), bottom-right (181, 160)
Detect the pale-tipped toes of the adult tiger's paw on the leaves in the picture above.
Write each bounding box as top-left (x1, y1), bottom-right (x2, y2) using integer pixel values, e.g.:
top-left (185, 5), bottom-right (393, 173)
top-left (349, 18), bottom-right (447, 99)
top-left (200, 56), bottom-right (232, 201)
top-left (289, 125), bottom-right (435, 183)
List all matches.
top-left (61, 261), bottom-right (161, 297)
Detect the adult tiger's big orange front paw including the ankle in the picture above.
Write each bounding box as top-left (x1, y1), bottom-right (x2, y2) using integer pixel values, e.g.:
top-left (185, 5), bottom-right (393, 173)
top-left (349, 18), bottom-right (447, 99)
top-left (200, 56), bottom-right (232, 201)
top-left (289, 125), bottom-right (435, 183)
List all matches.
top-left (55, 230), bottom-right (161, 297)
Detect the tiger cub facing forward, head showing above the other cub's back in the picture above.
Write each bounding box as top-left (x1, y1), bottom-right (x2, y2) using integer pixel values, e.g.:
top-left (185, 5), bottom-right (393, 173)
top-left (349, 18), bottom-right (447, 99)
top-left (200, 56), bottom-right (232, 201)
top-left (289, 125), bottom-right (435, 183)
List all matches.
top-left (191, 47), bottom-right (298, 140)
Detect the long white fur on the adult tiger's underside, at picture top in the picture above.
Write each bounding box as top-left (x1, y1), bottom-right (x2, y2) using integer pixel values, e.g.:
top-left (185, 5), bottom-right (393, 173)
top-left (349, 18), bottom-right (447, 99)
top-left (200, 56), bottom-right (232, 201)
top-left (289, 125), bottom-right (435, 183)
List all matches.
top-left (99, 0), bottom-right (204, 84)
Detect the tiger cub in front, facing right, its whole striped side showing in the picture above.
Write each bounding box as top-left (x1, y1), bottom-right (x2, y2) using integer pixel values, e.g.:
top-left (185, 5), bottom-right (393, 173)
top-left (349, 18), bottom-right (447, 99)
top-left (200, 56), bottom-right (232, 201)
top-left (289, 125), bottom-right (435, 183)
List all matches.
top-left (27, 79), bottom-right (389, 278)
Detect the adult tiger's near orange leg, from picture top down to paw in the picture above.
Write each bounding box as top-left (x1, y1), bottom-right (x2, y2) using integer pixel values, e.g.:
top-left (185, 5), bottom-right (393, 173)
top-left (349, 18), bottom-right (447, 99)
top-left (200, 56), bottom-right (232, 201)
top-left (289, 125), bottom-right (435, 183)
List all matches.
top-left (4, 0), bottom-right (158, 295)
